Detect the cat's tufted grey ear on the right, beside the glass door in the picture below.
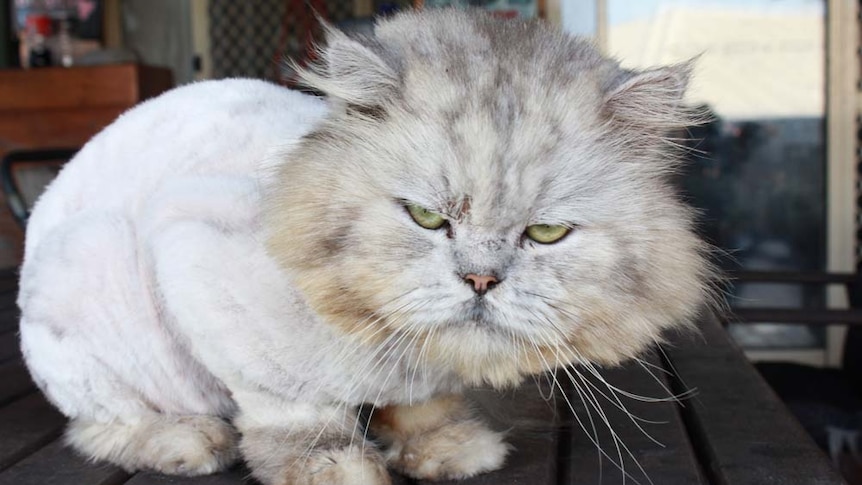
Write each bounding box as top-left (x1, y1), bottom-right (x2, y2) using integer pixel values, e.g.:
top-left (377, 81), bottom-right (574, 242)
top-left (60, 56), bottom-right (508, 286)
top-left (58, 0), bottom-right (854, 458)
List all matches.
top-left (604, 59), bottom-right (696, 131)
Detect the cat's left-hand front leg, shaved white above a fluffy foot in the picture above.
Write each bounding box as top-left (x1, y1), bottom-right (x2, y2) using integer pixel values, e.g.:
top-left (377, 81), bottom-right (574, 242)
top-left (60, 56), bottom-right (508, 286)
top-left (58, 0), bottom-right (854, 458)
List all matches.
top-left (234, 394), bottom-right (391, 485)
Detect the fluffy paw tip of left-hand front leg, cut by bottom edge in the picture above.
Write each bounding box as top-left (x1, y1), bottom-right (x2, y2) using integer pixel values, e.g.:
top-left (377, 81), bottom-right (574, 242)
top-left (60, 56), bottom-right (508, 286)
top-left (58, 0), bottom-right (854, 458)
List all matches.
top-left (283, 446), bottom-right (392, 485)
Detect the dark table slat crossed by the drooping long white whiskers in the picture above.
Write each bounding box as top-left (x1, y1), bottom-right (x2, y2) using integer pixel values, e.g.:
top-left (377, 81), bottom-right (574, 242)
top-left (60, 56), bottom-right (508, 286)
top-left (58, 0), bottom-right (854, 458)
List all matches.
top-left (561, 355), bottom-right (704, 485)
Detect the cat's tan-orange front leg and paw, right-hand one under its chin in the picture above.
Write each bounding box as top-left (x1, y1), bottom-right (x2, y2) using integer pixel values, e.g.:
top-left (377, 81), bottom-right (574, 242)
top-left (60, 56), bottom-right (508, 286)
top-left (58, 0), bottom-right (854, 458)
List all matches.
top-left (371, 395), bottom-right (509, 480)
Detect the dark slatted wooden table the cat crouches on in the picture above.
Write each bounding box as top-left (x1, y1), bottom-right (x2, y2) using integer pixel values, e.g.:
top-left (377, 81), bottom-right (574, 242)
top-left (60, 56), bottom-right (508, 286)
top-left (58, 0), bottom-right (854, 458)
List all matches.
top-left (0, 271), bottom-right (843, 485)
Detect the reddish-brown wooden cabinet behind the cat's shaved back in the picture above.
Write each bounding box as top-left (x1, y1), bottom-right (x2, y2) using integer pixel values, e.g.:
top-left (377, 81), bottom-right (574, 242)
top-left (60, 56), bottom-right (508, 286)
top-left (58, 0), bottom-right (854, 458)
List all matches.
top-left (0, 64), bottom-right (173, 268)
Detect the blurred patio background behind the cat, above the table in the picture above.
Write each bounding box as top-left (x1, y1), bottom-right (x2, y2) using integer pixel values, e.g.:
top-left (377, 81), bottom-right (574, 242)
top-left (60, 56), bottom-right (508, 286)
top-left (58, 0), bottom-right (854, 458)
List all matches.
top-left (0, 0), bottom-right (859, 365)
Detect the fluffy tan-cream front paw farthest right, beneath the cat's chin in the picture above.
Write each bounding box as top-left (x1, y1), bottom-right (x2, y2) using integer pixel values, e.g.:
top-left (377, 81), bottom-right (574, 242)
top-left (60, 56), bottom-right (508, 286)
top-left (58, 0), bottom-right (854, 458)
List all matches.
top-left (386, 420), bottom-right (510, 480)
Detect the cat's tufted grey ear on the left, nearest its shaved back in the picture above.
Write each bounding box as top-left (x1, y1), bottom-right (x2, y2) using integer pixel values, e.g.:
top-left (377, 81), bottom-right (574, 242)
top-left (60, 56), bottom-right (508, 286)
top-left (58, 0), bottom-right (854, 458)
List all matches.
top-left (295, 23), bottom-right (398, 110)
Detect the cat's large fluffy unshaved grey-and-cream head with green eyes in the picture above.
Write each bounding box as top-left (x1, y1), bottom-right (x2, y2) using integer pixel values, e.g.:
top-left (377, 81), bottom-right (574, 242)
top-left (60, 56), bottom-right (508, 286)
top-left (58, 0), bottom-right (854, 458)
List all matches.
top-left (266, 10), bottom-right (711, 386)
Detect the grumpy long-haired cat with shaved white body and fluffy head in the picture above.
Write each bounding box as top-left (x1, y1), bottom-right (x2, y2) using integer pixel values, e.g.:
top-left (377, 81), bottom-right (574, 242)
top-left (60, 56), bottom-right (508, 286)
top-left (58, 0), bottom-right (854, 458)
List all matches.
top-left (18, 10), bottom-right (713, 485)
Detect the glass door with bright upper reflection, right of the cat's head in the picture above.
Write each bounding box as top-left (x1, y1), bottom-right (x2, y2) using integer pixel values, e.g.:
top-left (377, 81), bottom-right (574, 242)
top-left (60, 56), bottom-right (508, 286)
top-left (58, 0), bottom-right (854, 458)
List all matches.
top-left (600, 0), bottom-right (827, 349)
